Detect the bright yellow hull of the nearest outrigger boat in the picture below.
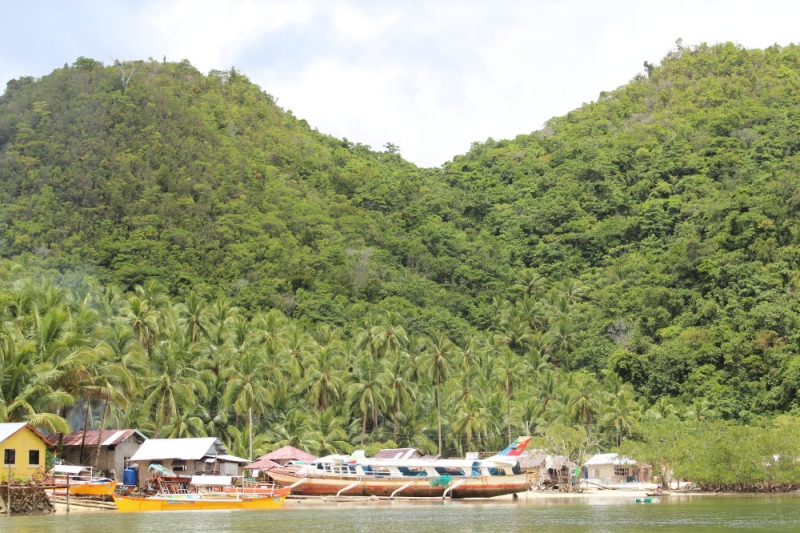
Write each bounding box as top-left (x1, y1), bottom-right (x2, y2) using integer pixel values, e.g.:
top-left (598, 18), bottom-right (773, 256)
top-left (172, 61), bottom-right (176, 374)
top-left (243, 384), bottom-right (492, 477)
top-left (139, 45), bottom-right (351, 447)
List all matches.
top-left (114, 494), bottom-right (286, 513)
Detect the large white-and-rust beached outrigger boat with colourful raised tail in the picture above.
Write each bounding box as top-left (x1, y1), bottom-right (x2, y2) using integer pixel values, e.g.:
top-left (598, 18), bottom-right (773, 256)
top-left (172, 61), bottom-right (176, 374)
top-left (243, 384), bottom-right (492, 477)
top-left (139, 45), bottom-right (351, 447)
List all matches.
top-left (267, 437), bottom-right (531, 499)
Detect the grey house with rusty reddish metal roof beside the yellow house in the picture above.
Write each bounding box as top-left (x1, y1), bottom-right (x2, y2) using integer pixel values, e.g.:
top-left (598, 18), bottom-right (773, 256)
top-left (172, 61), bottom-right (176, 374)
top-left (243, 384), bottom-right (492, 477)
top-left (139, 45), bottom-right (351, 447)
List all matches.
top-left (47, 429), bottom-right (147, 481)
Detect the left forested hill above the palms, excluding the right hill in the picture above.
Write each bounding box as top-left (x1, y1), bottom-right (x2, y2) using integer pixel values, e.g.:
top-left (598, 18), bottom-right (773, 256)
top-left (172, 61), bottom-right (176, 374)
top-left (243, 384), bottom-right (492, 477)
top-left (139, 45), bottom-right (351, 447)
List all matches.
top-left (0, 58), bottom-right (513, 333)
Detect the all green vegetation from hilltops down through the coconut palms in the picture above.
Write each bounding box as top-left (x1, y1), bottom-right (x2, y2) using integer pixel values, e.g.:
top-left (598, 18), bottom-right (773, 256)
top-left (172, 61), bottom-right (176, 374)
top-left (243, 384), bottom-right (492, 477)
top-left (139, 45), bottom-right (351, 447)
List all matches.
top-left (0, 42), bottom-right (800, 480)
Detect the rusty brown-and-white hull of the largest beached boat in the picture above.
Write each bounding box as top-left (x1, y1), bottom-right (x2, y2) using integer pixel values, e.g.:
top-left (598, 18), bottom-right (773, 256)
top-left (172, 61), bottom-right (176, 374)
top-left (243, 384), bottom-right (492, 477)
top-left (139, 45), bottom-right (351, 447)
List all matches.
top-left (268, 470), bottom-right (530, 498)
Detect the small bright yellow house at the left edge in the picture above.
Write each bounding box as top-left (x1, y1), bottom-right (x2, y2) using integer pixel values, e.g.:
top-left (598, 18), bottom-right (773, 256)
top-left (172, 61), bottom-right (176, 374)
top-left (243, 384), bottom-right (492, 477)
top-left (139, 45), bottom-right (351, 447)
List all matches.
top-left (0, 422), bottom-right (47, 481)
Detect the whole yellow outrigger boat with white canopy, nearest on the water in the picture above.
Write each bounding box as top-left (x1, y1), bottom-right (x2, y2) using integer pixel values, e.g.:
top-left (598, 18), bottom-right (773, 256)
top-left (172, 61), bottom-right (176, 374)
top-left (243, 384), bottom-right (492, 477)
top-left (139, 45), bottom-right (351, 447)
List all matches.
top-left (114, 476), bottom-right (291, 513)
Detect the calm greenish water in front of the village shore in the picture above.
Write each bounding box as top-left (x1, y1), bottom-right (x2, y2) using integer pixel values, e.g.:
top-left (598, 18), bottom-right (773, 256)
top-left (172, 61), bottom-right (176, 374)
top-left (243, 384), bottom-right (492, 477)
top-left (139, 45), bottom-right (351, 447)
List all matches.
top-left (0, 495), bottom-right (800, 533)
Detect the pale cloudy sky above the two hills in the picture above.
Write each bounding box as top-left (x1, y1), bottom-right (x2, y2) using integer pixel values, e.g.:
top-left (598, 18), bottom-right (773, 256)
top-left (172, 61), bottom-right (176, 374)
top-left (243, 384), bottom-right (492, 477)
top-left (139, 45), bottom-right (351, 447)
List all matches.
top-left (0, 0), bottom-right (800, 167)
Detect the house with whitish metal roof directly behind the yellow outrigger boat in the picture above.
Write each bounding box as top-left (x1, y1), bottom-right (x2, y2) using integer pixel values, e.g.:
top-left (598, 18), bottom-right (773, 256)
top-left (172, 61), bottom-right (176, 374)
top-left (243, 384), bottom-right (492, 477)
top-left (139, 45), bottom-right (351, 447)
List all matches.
top-left (130, 437), bottom-right (250, 487)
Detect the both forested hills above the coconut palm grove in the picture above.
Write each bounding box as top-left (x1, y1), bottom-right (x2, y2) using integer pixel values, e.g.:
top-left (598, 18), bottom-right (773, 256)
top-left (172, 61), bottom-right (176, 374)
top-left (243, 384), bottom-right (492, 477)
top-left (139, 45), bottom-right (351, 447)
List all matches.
top-left (0, 44), bottom-right (800, 420)
